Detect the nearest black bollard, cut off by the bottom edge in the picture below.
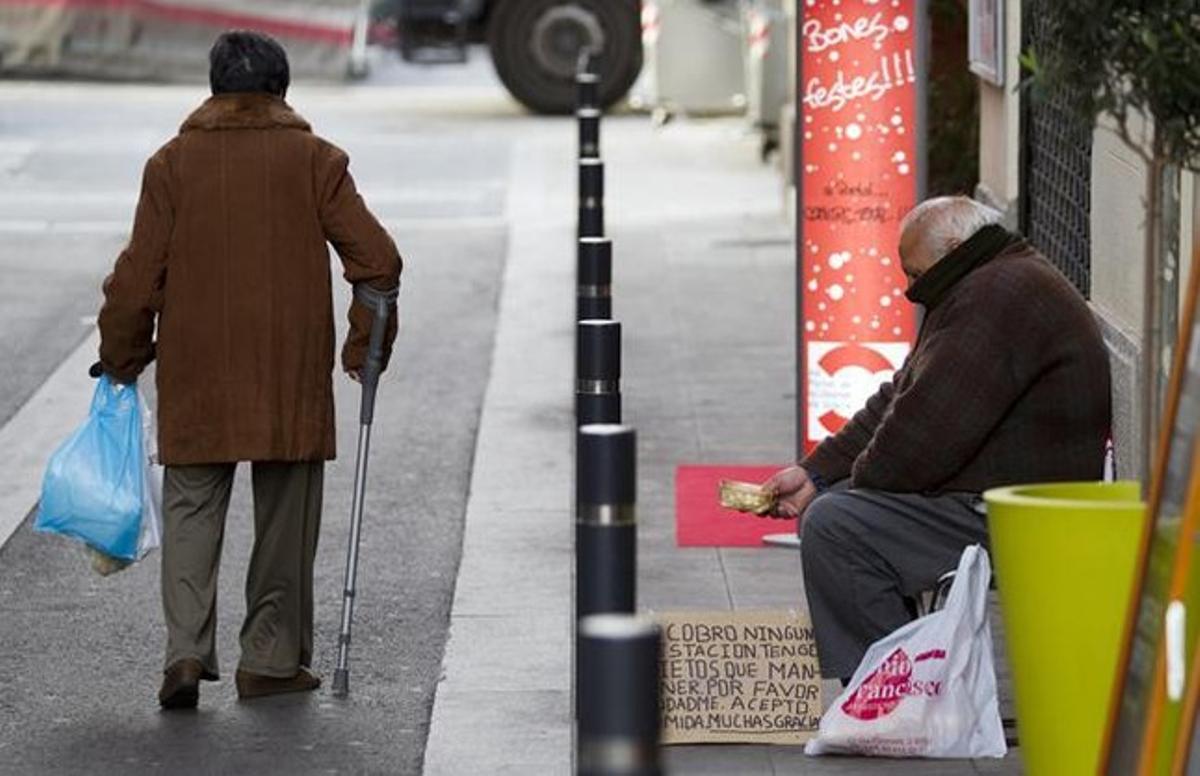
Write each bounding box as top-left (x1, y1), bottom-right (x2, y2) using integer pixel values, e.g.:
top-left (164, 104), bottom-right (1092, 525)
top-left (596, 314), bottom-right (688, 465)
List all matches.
top-left (576, 614), bottom-right (662, 776)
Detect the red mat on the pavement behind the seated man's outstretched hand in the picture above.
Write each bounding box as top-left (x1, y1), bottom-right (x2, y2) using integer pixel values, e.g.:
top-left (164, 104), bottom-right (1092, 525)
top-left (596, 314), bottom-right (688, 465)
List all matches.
top-left (676, 465), bottom-right (796, 547)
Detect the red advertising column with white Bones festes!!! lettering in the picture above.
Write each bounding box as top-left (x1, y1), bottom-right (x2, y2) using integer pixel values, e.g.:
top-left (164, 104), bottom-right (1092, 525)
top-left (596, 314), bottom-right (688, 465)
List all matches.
top-left (797, 0), bottom-right (924, 453)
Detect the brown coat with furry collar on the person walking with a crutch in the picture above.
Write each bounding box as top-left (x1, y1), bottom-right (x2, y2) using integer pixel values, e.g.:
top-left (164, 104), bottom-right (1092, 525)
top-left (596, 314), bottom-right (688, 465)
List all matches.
top-left (100, 94), bottom-right (401, 464)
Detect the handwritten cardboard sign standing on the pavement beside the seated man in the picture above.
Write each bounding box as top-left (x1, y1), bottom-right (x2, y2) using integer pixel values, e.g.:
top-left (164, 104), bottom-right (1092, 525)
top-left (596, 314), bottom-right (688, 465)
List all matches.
top-left (656, 612), bottom-right (821, 744)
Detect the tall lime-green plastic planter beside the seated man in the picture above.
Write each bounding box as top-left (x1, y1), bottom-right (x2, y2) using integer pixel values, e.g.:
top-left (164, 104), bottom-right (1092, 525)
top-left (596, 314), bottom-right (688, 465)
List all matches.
top-left (984, 482), bottom-right (1145, 776)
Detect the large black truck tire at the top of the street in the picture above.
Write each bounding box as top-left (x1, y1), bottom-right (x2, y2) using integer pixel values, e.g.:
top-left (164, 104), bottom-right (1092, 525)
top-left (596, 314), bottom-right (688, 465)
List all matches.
top-left (487, 0), bottom-right (642, 114)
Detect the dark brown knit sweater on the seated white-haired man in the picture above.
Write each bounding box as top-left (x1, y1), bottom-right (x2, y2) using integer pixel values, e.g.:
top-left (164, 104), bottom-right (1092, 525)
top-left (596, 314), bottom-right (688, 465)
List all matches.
top-left (800, 240), bottom-right (1111, 493)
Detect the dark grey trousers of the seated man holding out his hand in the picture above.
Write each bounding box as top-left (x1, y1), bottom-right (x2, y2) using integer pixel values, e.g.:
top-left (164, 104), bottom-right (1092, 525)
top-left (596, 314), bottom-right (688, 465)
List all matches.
top-left (800, 482), bottom-right (988, 679)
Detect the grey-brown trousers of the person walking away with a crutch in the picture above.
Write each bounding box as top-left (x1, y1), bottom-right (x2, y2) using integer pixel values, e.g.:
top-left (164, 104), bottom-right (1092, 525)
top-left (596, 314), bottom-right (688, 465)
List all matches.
top-left (162, 462), bottom-right (325, 679)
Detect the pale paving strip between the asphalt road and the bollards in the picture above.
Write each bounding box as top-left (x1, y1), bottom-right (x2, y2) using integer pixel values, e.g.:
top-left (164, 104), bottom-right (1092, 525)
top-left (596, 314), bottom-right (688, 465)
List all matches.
top-left (425, 116), bottom-right (575, 776)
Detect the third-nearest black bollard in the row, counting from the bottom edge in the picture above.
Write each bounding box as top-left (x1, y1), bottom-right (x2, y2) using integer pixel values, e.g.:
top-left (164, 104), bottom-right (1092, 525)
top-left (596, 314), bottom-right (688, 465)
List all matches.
top-left (575, 320), bottom-right (620, 426)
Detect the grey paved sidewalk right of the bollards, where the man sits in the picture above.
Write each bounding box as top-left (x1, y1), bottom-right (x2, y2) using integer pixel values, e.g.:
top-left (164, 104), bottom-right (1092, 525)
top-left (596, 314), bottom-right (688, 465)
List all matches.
top-left (606, 118), bottom-right (1020, 776)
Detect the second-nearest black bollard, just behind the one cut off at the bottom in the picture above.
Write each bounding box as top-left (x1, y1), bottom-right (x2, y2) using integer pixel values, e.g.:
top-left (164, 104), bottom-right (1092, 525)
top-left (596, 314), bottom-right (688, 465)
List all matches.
top-left (575, 423), bottom-right (637, 618)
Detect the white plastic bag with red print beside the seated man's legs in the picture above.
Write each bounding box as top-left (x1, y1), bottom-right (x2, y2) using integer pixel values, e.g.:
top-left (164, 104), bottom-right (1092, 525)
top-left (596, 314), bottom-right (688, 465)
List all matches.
top-left (804, 545), bottom-right (1007, 758)
